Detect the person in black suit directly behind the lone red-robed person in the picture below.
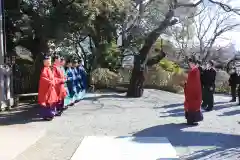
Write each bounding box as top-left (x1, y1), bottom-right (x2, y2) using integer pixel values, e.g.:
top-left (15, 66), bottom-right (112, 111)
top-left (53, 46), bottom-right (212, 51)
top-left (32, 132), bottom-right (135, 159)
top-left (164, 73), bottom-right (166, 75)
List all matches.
top-left (202, 61), bottom-right (216, 111)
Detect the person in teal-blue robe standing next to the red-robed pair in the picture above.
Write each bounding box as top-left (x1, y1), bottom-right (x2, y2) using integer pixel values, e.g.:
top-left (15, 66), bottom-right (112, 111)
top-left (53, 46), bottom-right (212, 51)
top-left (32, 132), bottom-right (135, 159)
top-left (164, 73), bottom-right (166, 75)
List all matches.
top-left (64, 60), bottom-right (76, 106)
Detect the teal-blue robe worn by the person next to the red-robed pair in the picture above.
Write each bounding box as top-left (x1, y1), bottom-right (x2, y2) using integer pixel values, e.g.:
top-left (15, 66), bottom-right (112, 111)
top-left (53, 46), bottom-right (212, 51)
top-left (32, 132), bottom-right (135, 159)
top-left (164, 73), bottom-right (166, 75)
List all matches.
top-left (64, 68), bottom-right (76, 105)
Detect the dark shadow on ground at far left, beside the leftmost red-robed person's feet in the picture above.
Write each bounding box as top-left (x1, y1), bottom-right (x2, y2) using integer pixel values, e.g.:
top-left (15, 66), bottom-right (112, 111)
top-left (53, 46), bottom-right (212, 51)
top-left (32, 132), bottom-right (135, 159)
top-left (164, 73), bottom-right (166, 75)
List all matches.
top-left (0, 104), bottom-right (42, 125)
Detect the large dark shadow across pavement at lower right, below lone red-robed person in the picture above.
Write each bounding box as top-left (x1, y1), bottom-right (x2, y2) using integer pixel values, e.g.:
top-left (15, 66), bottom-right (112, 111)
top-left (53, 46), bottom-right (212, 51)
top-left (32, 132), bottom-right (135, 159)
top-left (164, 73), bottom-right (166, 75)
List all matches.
top-left (133, 124), bottom-right (240, 159)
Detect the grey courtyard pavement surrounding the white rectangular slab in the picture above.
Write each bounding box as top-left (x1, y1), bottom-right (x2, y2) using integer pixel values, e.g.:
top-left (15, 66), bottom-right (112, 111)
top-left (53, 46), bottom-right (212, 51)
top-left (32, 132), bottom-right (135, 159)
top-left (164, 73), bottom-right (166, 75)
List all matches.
top-left (4, 90), bottom-right (240, 160)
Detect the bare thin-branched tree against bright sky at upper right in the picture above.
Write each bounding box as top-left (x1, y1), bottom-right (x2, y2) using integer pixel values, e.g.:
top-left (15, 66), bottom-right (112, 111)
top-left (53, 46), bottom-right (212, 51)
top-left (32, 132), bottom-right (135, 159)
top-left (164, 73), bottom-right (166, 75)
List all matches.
top-left (194, 2), bottom-right (240, 61)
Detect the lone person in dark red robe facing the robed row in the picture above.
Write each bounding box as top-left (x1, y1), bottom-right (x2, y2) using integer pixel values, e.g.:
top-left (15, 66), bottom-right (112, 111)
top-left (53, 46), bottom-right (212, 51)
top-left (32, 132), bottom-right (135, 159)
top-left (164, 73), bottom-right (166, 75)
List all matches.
top-left (184, 58), bottom-right (203, 125)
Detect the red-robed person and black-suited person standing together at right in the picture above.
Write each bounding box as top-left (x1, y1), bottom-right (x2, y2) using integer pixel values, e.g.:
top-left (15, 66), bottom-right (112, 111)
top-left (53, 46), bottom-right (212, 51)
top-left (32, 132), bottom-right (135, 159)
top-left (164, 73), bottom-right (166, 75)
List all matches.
top-left (184, 58), bottom-right (216, 125)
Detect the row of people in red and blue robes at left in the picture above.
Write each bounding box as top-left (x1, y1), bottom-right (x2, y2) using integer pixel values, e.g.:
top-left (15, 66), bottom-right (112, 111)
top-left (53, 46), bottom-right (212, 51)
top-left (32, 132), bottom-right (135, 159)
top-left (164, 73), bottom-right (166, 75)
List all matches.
top-left (38, 54), bottom-right (87, 120)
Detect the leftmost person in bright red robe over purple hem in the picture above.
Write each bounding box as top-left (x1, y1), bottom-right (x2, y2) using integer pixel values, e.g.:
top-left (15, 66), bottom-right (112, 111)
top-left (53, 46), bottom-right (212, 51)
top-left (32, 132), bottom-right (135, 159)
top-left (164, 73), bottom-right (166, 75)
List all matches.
top-left (38, 56), bottom-right (58, 120)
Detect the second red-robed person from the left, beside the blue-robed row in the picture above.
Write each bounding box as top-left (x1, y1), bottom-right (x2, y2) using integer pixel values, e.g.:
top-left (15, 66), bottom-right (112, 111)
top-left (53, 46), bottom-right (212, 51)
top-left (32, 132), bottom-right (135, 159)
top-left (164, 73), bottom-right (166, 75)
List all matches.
top-left (53, 55), bottom-right (67, 116)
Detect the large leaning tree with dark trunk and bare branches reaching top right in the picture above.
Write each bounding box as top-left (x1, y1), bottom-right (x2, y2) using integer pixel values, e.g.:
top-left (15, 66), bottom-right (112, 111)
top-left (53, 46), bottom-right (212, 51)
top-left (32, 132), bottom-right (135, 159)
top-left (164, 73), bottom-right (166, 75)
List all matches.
top-left (127, 0), bottom-right (240, 97)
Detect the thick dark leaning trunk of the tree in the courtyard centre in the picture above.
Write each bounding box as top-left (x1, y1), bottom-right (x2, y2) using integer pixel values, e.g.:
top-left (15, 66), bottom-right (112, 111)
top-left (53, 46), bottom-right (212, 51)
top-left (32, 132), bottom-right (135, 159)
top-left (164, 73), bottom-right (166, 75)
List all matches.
top-left (127, 11), bottom-right (177, 97)
